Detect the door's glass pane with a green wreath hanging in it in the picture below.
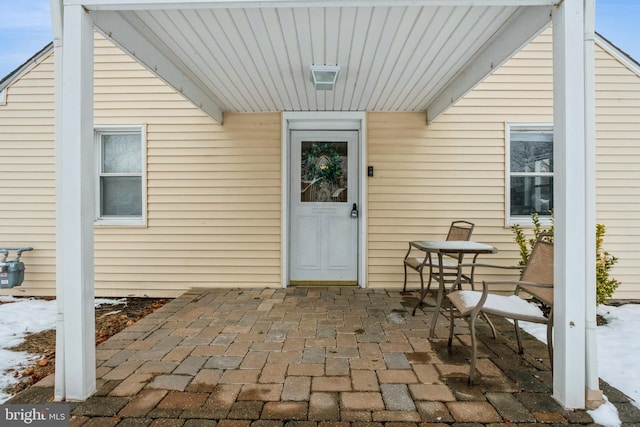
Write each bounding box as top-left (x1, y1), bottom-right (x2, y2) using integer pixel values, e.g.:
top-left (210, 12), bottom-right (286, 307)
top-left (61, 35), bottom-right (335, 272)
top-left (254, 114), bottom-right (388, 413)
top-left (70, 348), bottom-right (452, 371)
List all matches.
top-left (300, 141), bottom-right (348, 202)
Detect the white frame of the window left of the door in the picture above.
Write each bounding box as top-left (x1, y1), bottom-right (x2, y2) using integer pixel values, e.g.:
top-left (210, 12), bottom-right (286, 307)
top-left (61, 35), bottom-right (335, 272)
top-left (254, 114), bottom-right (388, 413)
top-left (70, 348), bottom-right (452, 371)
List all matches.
top-left (94, 125), bottom-right (147, 227)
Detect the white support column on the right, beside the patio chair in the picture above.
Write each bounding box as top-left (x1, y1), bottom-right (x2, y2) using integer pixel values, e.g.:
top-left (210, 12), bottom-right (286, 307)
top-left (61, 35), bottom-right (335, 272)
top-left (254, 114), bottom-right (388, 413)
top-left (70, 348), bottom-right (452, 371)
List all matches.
top-left (553, 0), bottom-right (594, 408)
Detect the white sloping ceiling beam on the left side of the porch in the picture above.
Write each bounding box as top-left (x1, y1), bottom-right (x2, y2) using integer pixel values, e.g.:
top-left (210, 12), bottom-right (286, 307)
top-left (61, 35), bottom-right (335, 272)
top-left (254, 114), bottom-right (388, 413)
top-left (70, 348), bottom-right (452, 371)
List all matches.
top-left (91, 12), bottom-right (223, 124)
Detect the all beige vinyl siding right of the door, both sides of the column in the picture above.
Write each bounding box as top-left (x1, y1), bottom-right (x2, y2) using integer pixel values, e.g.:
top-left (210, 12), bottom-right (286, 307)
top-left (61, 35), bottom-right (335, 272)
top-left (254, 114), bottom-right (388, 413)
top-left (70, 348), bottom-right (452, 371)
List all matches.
top-left (367, 31), bottom-right (640, 299)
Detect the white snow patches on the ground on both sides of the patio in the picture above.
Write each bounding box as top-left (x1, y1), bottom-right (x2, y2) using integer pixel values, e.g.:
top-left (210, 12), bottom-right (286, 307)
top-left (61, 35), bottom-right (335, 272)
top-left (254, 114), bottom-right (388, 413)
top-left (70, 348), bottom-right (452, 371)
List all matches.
top-left (0, 296), bottom-right (640, 427)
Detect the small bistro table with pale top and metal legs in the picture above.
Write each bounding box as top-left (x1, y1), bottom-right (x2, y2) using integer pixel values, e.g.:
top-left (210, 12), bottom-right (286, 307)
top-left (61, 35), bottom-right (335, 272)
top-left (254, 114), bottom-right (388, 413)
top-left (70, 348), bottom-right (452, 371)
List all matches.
top-left (410, 240), bottom-right (498, 338)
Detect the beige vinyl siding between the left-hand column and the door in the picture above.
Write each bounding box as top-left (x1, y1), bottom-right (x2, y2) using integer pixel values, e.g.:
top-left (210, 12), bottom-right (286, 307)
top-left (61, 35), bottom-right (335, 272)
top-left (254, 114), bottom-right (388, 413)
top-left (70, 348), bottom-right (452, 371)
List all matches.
top-left (95, 38), bottom-right (281, 295)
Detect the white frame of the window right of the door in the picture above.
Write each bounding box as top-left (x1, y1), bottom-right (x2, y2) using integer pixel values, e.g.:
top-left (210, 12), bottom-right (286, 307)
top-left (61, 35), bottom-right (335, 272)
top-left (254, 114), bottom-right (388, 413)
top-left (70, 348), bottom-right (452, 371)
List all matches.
top-left (505, 123), bottom-right (555, 227)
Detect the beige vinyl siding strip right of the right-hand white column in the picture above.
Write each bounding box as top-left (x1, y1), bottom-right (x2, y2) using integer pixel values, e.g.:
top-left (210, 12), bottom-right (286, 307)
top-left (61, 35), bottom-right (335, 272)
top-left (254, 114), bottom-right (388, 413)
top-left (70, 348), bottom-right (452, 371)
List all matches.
top-left (595, 42), bottom-right (640, 299)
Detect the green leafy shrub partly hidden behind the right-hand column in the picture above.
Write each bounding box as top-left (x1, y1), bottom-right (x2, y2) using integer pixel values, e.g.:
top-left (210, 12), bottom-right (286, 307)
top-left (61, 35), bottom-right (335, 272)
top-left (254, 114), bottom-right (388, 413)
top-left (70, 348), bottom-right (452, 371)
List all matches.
top-left (511, 216), bottom-right (620, 305)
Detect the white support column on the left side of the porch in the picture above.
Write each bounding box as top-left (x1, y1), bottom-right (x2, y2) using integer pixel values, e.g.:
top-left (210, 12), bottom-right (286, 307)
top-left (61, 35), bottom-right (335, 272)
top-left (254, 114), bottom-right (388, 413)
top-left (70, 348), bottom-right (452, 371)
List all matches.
top-left (56, 5), bottom-right (96, 400)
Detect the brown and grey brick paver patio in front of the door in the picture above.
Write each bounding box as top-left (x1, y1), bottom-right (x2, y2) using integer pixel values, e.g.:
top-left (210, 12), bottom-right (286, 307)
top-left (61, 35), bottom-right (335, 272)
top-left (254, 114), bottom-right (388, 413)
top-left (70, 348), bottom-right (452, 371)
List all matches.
top-left (8, 287), bottom-right (640, 427)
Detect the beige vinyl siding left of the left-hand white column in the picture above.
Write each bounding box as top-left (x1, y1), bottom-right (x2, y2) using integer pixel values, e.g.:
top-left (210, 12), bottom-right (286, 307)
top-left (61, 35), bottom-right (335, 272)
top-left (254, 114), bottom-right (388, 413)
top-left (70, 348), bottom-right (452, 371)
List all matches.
top-left (0, 53), bottom-right (56, 295)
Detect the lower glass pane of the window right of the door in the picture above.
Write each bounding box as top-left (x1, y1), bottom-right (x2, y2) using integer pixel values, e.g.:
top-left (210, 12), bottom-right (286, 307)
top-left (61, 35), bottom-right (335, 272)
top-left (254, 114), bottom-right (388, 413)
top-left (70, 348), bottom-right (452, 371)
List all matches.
top-left (511, 176), bottom-right (553, 216)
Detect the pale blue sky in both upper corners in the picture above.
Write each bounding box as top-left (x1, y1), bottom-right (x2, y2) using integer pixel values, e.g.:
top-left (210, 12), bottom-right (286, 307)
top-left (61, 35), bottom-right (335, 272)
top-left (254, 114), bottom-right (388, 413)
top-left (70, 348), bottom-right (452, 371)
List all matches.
top-left (0, 0), bottom-right (640, 79)
